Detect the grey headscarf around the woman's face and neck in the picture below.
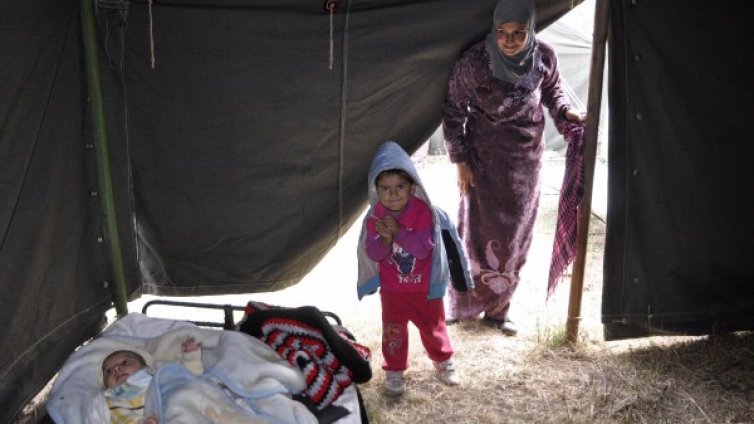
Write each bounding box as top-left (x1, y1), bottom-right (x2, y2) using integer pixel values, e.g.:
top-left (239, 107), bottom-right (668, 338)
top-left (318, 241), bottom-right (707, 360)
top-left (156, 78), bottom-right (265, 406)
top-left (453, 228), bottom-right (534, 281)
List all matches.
top-left (486, 0), bottom-right (537, 82)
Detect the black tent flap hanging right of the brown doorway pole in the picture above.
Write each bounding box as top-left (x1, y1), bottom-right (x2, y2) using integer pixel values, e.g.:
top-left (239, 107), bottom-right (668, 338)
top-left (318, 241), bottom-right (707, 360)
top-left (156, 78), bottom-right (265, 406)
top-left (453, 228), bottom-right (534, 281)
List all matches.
top-left (602, 1), bottom-right (754, 340)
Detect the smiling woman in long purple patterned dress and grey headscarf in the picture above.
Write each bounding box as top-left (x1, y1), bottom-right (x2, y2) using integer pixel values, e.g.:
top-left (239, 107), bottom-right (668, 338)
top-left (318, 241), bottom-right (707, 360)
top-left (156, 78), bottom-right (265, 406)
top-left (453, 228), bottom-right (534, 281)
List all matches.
top-left (443, 0), bottom-right (585, 336)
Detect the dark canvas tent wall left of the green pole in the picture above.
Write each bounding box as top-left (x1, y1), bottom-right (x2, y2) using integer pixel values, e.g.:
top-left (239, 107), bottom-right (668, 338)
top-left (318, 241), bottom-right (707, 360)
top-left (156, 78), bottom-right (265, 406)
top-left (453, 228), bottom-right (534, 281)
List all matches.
top-left (0, 1), bottom-right (111, 422)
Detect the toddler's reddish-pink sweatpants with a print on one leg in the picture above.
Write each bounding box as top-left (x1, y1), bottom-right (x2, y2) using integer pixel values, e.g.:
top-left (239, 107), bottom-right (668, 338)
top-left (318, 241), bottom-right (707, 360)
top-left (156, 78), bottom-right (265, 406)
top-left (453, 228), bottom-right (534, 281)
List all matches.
top-left (380, 290), bottom-right (453, 371)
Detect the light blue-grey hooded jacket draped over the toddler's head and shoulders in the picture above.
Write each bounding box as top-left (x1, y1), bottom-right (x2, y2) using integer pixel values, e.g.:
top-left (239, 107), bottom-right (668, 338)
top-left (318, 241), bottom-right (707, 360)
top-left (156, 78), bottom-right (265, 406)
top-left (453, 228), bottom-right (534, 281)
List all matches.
top-left (356, 141), bottom-right (474, 299)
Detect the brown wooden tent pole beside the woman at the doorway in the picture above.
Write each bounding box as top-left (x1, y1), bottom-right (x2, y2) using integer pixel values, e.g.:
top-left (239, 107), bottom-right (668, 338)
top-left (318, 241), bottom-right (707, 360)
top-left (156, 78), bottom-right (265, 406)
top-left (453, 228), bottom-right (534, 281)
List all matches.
top-left (566, 0), bottom-right (610, 345)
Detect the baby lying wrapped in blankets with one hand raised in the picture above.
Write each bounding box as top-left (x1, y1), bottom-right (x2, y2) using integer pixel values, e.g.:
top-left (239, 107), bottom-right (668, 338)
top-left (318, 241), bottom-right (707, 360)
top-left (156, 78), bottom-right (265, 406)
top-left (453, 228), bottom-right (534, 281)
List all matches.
top-left (102, 337), bottom-right (203, 424)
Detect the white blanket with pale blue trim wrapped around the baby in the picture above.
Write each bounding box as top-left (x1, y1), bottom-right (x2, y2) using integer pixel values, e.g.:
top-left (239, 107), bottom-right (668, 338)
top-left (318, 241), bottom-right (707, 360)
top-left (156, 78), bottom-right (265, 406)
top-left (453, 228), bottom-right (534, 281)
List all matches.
top-left (47, 313), bottom-right (317, 424)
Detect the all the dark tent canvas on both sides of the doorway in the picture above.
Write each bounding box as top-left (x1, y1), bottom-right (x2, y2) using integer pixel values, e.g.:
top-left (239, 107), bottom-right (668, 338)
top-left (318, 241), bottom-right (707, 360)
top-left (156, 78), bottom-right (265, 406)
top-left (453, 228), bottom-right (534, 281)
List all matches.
top-left (0, 0), bottom-right (754, 421)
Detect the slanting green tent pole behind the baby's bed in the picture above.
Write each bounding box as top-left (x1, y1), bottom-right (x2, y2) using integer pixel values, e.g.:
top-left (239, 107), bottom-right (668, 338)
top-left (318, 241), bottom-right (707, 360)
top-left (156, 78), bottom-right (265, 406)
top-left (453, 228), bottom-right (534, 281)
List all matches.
top-left (81, 0), bottom-right (128, 316)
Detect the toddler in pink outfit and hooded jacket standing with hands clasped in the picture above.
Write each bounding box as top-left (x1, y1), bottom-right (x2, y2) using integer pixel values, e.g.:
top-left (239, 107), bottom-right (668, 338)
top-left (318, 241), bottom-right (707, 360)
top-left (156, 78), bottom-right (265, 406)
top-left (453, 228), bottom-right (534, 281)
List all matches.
top-left (358, 142), bottom-right (468, 394)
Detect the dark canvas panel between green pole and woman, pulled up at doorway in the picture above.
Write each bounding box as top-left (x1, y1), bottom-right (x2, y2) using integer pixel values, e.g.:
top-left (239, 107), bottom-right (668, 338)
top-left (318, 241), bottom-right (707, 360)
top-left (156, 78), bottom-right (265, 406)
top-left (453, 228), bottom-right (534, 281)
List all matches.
top-left (99, 0), bottom-right (506, 295)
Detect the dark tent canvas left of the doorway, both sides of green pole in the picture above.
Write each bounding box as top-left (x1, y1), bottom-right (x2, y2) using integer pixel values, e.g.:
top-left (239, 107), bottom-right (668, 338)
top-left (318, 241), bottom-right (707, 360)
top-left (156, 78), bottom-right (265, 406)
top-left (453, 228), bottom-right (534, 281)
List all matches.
top-left (0, 0), bottom-right (567, 421)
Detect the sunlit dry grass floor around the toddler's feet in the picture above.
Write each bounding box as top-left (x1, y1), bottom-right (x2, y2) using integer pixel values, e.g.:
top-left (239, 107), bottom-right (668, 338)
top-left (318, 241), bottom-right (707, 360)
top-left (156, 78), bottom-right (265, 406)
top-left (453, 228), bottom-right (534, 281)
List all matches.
top-left (361, 322), bottom-right (754, 424)
